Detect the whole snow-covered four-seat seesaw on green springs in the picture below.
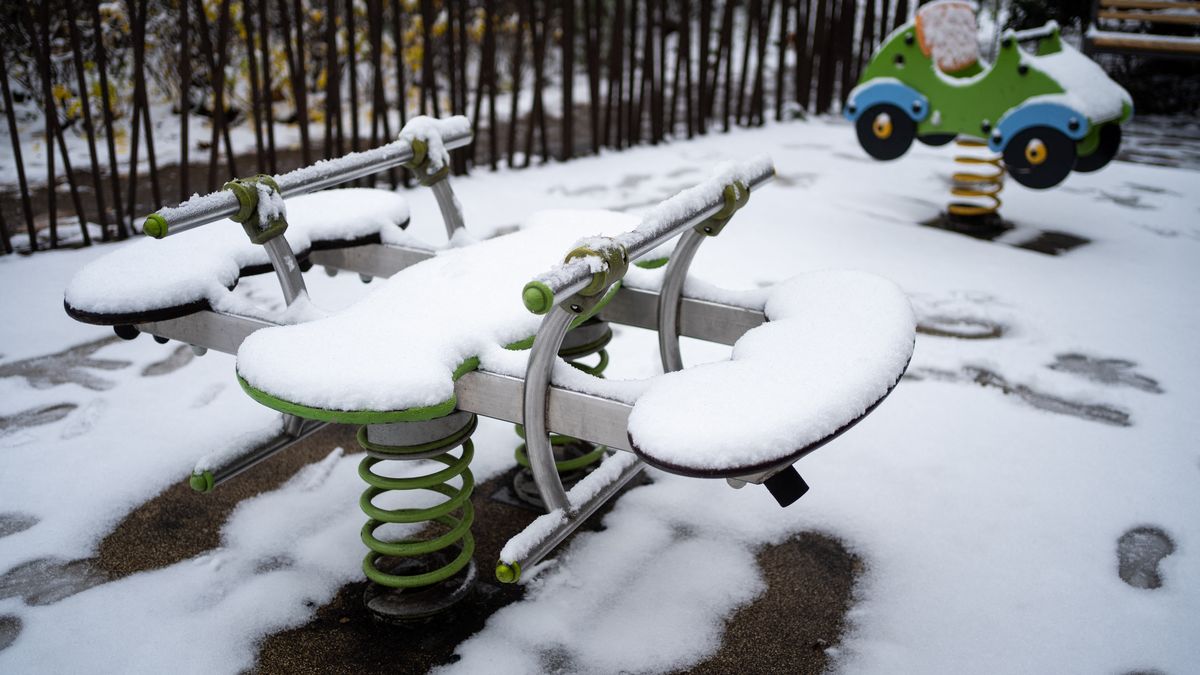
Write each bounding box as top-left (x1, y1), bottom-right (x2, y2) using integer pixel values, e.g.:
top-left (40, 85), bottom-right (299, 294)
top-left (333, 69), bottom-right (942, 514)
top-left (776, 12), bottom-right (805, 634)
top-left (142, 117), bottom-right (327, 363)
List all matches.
top-left (65, 118), bottom-right (914, 620)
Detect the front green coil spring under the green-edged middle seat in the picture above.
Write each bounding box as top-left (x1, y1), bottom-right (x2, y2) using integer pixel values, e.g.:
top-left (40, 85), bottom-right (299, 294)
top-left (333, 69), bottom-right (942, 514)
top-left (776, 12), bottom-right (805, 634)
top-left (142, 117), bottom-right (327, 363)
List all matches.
top-left (359, 416), bottom-right (476, 589)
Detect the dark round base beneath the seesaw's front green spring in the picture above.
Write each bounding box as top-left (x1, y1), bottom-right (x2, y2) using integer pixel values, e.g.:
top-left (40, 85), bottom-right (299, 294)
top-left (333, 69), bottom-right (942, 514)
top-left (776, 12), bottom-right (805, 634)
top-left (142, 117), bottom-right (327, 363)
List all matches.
top-left (362, 548), bottom-right (479, 625)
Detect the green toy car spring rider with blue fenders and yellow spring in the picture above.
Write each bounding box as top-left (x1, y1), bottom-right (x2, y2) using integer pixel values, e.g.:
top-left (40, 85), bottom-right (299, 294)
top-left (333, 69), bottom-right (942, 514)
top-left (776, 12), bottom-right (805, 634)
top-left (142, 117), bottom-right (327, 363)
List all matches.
top-left (844, 0), bottom-right (1133, 236)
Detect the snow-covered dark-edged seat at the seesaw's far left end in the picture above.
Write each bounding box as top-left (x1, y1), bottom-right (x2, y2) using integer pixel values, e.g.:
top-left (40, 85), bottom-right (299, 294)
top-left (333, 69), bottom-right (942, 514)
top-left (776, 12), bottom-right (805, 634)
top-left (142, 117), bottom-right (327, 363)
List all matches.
top-left (65, 187), bottom-right (409, 325)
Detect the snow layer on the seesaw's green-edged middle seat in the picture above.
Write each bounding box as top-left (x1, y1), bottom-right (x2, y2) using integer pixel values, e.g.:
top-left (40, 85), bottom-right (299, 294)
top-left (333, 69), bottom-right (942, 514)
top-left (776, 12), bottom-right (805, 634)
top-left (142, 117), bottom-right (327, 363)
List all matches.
top-left (238, 211), bottom-right (648, 411)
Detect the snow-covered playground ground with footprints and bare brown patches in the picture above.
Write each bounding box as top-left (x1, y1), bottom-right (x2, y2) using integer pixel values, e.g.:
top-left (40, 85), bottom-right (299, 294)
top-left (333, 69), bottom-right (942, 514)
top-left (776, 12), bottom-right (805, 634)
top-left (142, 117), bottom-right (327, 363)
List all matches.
top-left (0, 119), bottom-right (1200, 673)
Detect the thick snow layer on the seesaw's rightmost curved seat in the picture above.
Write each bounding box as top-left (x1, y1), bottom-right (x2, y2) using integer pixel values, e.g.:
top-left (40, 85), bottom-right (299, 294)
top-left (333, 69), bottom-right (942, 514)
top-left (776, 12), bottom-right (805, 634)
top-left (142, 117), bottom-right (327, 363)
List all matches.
top-left (629, 271), bottom-right (916, 472)
